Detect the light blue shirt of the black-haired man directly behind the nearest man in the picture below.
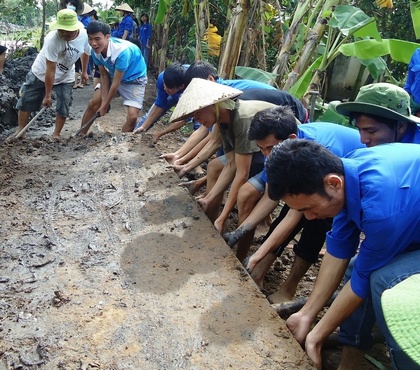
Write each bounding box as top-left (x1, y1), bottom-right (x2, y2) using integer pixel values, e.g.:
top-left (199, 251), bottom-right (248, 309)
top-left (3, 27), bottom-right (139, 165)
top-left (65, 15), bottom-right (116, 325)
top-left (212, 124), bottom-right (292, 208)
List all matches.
top-left (262, 122), bottom-right (366, 182)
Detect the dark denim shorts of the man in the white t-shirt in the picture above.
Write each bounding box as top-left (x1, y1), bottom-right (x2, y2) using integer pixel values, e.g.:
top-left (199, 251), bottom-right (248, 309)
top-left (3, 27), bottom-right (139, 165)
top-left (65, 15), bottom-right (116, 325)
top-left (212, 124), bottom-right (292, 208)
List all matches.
top-left (16, 72), bottom-right (73, 117)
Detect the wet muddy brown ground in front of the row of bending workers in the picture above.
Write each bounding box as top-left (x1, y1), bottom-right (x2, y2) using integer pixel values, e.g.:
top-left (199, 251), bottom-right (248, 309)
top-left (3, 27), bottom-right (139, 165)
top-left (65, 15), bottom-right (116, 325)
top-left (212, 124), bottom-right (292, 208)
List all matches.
top-left (0, 71), bottom-right (390, 370)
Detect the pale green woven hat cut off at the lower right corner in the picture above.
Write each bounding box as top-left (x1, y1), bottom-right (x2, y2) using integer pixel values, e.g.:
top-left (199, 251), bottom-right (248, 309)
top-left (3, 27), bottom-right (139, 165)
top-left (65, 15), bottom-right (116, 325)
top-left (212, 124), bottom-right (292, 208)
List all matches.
top-left (381, 274), bottom-right (420, 365)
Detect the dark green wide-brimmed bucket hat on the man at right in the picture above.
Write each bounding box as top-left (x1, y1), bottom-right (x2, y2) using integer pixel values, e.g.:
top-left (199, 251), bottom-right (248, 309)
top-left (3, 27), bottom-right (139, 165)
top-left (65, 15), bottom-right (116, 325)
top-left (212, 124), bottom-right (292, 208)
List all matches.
top-left (335, 82), bottom-right (420, 123)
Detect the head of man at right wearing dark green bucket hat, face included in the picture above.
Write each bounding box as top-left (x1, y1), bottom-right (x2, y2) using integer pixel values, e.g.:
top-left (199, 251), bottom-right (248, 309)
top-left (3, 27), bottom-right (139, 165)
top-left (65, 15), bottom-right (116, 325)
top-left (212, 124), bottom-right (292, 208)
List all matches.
top-left (336, 83), bottom-right (420, 147)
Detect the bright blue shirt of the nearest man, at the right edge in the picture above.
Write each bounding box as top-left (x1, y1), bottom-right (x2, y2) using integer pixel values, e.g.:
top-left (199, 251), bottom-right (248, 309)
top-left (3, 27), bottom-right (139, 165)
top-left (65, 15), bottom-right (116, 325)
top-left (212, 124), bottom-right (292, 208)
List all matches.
top-left (327, 143), bottom-right (420, 298)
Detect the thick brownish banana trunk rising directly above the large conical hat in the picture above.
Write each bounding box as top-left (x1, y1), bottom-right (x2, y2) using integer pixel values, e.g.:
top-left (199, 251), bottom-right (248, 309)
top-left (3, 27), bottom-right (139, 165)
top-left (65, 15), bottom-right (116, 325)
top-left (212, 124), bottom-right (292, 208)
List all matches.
top-left (219, 0), bottom-right (250, 78)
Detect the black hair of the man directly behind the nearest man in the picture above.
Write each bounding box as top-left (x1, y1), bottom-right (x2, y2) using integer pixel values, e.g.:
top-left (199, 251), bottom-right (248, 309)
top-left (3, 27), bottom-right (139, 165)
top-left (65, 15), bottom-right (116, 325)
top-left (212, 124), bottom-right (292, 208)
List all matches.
top-left (248, 105), bottom-right (298, 140)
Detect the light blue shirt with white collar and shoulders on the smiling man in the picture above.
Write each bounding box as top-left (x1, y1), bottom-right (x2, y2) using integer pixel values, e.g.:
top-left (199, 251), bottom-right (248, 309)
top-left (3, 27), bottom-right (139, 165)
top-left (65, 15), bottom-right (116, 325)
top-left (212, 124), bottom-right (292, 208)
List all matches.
top-left (92, 37), bottom-right (147, 83)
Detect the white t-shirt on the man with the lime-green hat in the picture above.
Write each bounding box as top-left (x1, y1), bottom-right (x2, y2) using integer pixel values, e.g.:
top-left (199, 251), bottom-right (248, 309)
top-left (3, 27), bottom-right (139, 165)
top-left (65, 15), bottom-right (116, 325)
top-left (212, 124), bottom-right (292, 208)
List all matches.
top-left (31, 28), bottom-right (91, 85)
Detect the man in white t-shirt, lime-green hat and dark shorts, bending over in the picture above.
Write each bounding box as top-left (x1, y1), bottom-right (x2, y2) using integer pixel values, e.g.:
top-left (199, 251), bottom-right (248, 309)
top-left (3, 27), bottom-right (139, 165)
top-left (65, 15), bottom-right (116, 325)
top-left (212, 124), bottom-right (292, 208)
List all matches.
top-left (16, 9), bottom-right (90, 137)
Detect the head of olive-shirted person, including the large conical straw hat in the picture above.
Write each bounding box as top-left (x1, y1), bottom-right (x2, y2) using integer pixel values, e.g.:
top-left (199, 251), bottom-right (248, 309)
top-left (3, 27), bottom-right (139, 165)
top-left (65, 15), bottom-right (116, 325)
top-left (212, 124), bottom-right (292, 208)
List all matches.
top-left (170, 78), bottom-right (242, 128)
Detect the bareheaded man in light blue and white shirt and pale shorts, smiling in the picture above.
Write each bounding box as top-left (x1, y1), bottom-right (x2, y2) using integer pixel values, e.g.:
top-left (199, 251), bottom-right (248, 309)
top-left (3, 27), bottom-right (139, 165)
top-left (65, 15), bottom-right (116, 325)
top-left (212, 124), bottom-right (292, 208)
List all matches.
top-left (82, 21), bottom-right (147, 134)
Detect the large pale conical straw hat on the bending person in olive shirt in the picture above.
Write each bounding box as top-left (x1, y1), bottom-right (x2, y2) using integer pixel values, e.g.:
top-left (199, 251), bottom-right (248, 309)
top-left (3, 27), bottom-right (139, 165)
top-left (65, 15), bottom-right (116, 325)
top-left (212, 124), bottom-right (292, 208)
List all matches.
top-left (170, 78), bottom-right (242, 122)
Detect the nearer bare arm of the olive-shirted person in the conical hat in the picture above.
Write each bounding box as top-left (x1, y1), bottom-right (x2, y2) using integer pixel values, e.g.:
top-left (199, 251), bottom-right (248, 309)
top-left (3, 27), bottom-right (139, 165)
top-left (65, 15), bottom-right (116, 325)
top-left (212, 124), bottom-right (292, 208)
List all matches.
top-left (214, 153), bottom-right (252, 233)
